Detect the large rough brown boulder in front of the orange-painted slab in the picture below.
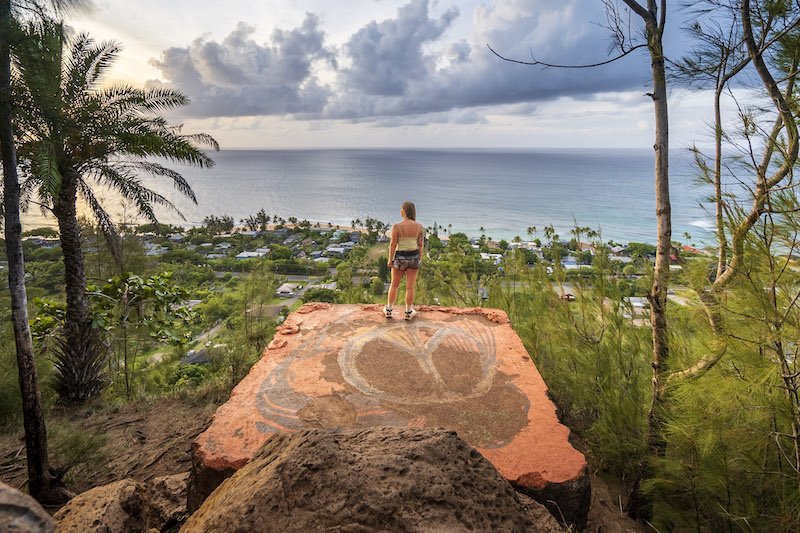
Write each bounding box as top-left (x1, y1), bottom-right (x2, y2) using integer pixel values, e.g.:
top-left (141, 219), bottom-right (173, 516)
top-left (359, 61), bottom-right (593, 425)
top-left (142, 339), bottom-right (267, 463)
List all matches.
top-left (181, 427), bottom-right (561, 533)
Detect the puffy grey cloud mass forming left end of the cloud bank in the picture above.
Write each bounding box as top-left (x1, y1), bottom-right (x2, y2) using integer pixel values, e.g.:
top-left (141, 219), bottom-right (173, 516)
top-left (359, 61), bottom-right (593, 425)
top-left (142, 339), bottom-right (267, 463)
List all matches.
top-left (149, 14), bottom-right (335, 116)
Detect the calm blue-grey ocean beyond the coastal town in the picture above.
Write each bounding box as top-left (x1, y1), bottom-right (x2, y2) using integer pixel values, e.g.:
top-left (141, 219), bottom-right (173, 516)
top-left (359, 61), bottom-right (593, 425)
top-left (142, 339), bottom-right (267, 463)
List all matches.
top-left (28, 149), bottom-right (713, 244)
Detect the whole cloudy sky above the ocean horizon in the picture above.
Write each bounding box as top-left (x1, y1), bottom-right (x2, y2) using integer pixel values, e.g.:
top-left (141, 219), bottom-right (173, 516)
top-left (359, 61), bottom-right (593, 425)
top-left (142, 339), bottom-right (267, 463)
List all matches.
top-left (68, 0), bottom-right (732, 149)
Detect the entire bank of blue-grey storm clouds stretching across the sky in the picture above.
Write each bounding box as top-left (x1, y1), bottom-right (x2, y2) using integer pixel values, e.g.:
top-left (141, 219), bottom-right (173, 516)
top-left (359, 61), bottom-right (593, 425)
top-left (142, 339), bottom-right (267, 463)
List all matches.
top-left (148, 0), bottom-right (676, 121)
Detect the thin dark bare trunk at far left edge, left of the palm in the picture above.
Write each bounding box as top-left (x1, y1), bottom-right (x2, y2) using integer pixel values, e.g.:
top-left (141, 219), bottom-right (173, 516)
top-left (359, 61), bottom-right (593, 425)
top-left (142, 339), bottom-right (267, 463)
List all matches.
top-left (0, 0), bottom-right (52, 501)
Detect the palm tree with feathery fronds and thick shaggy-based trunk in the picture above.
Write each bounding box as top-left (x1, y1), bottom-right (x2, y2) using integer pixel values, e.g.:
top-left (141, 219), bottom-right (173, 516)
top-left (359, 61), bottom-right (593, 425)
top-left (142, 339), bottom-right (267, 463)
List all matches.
top-left (17, 22), bottom-right (217, 401)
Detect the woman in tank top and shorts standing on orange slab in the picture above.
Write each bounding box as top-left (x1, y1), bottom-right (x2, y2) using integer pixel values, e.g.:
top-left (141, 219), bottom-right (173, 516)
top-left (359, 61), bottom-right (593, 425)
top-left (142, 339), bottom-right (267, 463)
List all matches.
top-left (383, 202), bottom-right (425, 320)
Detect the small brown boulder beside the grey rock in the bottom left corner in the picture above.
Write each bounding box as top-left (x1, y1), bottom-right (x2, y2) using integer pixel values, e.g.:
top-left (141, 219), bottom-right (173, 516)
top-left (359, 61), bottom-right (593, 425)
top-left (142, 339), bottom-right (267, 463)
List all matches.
top-left (53, 479), bottom-right (145, 533)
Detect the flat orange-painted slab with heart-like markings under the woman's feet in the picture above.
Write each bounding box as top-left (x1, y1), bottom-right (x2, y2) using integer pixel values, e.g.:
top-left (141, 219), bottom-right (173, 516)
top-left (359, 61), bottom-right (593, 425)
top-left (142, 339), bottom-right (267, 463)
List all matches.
top-left (189, 303), bottom-right (590, 525)
